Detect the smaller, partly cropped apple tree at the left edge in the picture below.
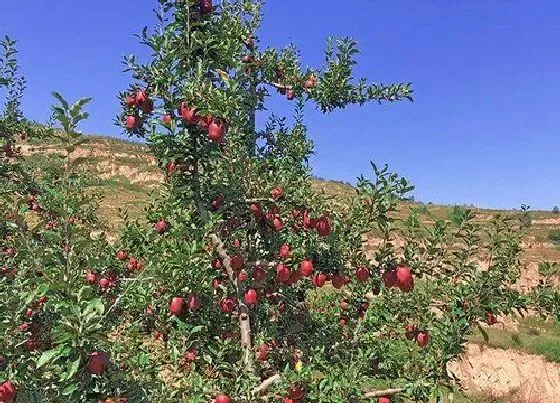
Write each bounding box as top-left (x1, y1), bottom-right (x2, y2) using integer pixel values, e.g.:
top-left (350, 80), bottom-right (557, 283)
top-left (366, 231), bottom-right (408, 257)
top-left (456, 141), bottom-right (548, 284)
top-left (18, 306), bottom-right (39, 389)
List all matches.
top-left (0, 44), bottom-right (143, 403)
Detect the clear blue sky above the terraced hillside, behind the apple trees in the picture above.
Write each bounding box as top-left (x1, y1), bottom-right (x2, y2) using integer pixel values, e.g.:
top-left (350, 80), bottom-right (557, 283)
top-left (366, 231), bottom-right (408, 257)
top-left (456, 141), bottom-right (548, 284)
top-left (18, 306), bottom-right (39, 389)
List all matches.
top-left (0, 0), bottom-right (560, 210)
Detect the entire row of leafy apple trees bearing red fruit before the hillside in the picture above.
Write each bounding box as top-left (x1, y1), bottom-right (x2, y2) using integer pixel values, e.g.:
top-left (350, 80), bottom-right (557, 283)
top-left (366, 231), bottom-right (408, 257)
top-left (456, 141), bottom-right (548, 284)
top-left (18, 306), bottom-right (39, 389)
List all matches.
top-left (0, 0), bottom-right (550, 403)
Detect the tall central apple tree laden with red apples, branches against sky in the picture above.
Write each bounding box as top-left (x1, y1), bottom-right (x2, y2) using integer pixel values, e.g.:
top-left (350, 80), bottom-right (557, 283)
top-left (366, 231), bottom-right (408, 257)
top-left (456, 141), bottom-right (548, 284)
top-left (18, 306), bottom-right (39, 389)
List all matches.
top-left (113, 0), bottom-right (525, 403)
